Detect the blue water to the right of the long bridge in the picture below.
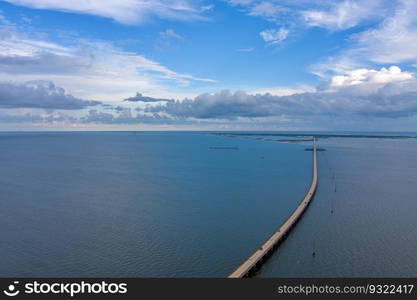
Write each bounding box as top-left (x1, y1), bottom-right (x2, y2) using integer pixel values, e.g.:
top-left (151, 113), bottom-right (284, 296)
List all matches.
top-left (258, 138), bottom-right (417, 277)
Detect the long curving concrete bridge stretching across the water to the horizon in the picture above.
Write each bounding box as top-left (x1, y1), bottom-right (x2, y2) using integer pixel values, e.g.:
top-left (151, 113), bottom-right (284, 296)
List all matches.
top-left (228, 139), bottom-right (317, 278)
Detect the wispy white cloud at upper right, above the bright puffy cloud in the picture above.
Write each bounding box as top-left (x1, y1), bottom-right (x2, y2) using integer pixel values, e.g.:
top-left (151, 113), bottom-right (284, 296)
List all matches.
top-left (311, 0), bottom-right (417, 77)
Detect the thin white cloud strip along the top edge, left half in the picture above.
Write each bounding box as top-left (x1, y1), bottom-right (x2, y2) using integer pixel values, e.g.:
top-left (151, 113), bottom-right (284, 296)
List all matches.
top-left (1, 0), bottom-right (204, 24)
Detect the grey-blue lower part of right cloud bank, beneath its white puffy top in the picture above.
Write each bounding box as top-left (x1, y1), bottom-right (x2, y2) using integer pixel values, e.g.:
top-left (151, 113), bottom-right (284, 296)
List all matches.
top-left (145, 90), bottom-right (417, 120)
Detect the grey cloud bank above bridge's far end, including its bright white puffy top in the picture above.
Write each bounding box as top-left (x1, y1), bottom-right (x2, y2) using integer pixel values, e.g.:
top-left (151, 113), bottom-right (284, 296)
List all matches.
top-left (145, 67), bottom-right (417, 120)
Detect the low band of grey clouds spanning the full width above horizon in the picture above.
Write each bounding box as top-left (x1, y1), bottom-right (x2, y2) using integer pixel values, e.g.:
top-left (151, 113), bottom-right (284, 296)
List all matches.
top-left (0, 66), bottom-right (417, 129)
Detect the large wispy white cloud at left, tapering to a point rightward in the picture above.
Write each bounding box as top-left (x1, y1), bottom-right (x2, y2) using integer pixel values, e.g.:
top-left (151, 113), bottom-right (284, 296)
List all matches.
top-left (0, 17), bottom-right (213, 101)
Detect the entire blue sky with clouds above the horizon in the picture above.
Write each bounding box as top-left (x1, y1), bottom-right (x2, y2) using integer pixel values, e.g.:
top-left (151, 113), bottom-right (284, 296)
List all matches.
top-left (0, 0), bottom-right (417, 131)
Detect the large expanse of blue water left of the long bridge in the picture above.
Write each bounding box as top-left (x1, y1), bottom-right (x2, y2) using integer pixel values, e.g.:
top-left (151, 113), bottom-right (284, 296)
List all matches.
top-left (0, 132), bottom-right (311, 277)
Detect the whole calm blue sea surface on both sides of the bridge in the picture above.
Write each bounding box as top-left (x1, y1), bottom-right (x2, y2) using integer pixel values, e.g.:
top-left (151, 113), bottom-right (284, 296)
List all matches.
top-left (0, 132), bottom-right (417, 277)
